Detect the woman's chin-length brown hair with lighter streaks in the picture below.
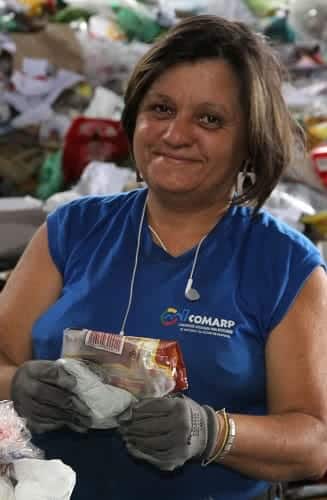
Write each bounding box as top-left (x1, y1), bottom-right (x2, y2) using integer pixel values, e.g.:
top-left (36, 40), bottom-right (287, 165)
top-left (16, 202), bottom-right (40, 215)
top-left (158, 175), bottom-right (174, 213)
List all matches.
top-left (122, 15), bottom-right (304, 212)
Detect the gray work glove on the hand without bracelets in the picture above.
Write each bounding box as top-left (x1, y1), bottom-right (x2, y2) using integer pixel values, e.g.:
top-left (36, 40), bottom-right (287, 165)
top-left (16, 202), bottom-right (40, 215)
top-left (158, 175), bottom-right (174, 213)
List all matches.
top-left (11, 361), bottom-right (90, 433)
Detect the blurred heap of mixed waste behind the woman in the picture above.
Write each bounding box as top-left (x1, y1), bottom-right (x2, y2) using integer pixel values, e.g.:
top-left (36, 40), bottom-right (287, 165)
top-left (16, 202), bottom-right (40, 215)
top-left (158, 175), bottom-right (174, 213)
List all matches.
top-left (0, 0), bottom-right (327, 498)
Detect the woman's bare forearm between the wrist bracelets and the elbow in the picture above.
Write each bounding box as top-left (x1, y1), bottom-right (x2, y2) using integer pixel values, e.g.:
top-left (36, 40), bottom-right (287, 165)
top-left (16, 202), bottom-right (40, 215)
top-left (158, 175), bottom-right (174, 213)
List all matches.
top-left (223, 413), bottom-right (327, 481)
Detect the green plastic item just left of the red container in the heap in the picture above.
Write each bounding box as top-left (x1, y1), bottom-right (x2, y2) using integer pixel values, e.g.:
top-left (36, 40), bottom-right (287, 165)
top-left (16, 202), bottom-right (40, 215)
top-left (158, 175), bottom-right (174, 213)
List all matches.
top-left (35, 150), bottom-right (64, 200)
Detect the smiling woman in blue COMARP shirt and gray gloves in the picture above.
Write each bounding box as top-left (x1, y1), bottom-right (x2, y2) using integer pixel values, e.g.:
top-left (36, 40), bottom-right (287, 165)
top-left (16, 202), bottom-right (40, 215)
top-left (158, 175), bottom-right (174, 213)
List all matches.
top-left (0, 16), bottom-right (327, 500)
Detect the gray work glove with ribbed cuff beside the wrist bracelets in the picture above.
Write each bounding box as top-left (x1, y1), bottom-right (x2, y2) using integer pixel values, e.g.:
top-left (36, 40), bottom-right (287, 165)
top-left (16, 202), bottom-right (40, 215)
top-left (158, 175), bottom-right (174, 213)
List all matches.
top-left (120, 395), bottom-right (219, 471)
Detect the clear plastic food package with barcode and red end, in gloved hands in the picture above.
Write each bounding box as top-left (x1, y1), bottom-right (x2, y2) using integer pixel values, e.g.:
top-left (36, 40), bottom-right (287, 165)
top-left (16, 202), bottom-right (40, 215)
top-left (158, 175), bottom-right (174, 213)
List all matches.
top-left (61, 328), bottom-right (188, 399)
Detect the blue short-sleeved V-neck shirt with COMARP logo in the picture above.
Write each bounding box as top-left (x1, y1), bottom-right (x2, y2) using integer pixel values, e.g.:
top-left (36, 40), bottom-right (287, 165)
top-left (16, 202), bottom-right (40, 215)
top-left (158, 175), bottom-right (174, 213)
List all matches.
top-left (33, 190), bottom-right (323, 500)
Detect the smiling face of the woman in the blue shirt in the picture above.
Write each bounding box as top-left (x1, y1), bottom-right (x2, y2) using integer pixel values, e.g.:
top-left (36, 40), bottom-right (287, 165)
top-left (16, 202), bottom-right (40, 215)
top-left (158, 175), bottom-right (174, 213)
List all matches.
top-left (133, 59), bottom-right (246, 207)
